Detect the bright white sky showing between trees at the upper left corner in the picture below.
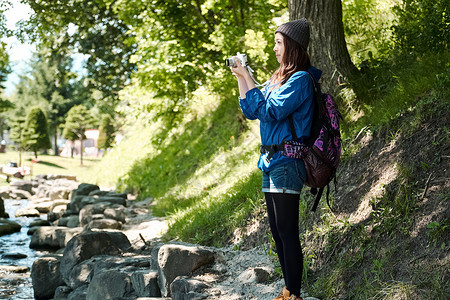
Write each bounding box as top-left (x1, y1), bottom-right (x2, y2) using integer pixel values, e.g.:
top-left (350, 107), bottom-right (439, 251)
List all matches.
top-left (2, 0), bottom-right (36, 95)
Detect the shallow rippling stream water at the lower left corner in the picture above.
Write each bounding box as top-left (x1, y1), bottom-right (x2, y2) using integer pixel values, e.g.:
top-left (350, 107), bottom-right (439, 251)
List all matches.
top-left (0, 199), bottom-right (47, 300)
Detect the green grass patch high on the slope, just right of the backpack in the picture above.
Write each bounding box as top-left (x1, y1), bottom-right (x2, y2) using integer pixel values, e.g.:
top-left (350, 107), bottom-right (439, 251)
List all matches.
top-left (340, 51), bottom-right (450, 139)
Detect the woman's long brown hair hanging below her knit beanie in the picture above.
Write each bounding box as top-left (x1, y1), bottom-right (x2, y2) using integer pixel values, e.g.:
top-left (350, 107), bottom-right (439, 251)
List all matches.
top-left (270, 32), bottom-right (311, 86)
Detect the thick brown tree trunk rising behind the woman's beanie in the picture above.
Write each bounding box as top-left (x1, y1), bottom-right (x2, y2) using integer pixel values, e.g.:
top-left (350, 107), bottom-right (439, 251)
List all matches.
top-left (288, 0), bottom-right (358, 93)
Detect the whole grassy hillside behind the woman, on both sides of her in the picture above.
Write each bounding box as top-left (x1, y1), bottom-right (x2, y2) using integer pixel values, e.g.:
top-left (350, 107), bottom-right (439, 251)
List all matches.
top-left (85, 55), bottom-right (450, 299)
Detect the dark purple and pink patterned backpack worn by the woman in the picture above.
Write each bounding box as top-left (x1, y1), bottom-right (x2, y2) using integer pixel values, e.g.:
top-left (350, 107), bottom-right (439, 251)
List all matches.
top-left (282, 73), bottom-right (342, 211)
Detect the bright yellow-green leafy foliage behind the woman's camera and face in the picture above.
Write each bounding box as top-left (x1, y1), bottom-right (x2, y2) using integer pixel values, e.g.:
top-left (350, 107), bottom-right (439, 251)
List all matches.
top-left (114, 0), bottom-right (286, 114)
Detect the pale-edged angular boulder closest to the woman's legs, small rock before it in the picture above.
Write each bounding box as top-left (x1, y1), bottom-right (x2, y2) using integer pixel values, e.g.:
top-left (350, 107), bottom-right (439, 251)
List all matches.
top-left (158, 244), bottom-right (215, 297)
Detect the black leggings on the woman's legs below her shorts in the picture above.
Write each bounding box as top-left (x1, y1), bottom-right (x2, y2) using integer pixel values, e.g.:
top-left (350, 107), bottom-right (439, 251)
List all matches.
top-left (265, 193), bottom-right (303, 296)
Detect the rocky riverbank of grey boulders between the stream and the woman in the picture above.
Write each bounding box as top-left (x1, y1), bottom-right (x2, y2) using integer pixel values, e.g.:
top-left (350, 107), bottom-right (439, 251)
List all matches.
top-left (0, 176), bottom-right (314, 300)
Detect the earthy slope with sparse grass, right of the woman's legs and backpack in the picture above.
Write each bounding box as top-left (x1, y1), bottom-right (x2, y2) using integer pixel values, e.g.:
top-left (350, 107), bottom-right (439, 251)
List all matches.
top-left (303, 95), bottom-right (450, 299)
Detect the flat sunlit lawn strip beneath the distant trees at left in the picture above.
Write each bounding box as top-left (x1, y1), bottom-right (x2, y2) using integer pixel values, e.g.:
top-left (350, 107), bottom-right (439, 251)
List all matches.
top-left (0, 150), bottom-right (100, 185)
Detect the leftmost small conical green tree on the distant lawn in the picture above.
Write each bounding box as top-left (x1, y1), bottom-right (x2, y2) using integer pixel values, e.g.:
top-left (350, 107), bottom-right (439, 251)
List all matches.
top-left (23, 107), bottom-right (51, 158)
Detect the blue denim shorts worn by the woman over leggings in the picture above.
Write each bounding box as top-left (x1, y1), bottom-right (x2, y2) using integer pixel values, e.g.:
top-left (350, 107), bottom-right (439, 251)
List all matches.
top-left (262, 159), bottom-right (306, 194)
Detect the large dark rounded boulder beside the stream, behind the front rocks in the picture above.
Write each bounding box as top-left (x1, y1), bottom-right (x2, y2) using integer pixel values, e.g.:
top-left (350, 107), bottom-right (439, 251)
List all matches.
top-left (61, 231), bottom-right (131, 285)
